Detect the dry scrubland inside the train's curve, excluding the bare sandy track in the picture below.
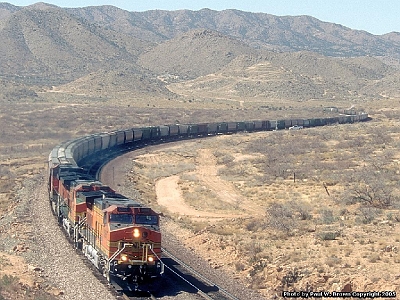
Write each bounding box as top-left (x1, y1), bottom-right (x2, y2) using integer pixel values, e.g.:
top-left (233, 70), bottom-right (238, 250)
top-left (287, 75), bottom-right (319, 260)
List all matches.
top-left (122, 98), bottom-right (400, 295)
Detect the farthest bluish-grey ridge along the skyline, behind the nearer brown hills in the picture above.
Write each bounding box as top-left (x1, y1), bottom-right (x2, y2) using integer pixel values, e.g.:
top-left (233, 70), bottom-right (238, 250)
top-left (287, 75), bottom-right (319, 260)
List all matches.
top-left (68, 6), bottom-right (400, 58)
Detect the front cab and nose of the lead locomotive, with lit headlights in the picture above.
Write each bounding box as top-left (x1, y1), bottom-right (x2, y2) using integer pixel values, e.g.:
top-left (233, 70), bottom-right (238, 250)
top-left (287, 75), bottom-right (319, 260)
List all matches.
top-left (103, 200), bottom-right (163, 282)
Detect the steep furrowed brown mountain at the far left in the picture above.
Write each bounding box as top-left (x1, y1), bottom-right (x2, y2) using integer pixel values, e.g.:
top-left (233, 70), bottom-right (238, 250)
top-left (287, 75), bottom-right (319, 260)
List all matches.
top-left (0, 3), bottom-right (148, 85)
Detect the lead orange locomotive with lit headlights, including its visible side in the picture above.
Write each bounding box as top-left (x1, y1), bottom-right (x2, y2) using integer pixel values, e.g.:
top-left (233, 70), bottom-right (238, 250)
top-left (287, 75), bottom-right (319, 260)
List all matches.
top-left (87, 194), bottom-right (164, 283)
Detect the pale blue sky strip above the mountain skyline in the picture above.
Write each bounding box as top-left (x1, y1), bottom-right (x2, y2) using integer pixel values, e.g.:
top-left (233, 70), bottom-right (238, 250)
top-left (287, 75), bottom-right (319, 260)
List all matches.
top-left (6, 0), bottom-right (400, 34)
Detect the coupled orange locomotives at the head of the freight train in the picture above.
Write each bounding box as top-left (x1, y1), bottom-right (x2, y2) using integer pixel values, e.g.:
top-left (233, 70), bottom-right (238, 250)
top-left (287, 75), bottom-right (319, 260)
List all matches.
top-left (49, 148), bottom-right (164, 288)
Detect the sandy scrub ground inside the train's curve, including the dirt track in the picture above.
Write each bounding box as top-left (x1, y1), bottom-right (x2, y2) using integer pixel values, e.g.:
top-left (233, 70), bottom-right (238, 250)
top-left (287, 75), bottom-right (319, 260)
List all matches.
top-left (102, 110), bottom-right (400, 298)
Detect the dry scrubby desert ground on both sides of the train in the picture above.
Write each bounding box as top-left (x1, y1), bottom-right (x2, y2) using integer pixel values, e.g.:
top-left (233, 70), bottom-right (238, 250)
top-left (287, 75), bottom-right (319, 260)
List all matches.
top-left (0, 95), bottom-right (400, 299)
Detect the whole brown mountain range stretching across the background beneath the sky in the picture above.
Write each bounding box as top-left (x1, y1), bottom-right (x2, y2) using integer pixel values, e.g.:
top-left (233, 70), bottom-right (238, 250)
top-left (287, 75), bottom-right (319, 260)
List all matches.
top-left (0, 2), bottom-right (400, 101)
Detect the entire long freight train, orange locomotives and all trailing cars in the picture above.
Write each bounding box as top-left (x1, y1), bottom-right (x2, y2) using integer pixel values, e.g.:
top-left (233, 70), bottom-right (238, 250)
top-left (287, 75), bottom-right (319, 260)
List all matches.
top-left (48, 113), bottom-right (368, 285)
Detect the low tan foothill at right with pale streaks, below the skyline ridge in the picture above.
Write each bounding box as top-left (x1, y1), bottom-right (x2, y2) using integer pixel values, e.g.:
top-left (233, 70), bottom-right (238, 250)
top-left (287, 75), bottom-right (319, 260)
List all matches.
top-left (168, 52), bottom-right (400, 101)
